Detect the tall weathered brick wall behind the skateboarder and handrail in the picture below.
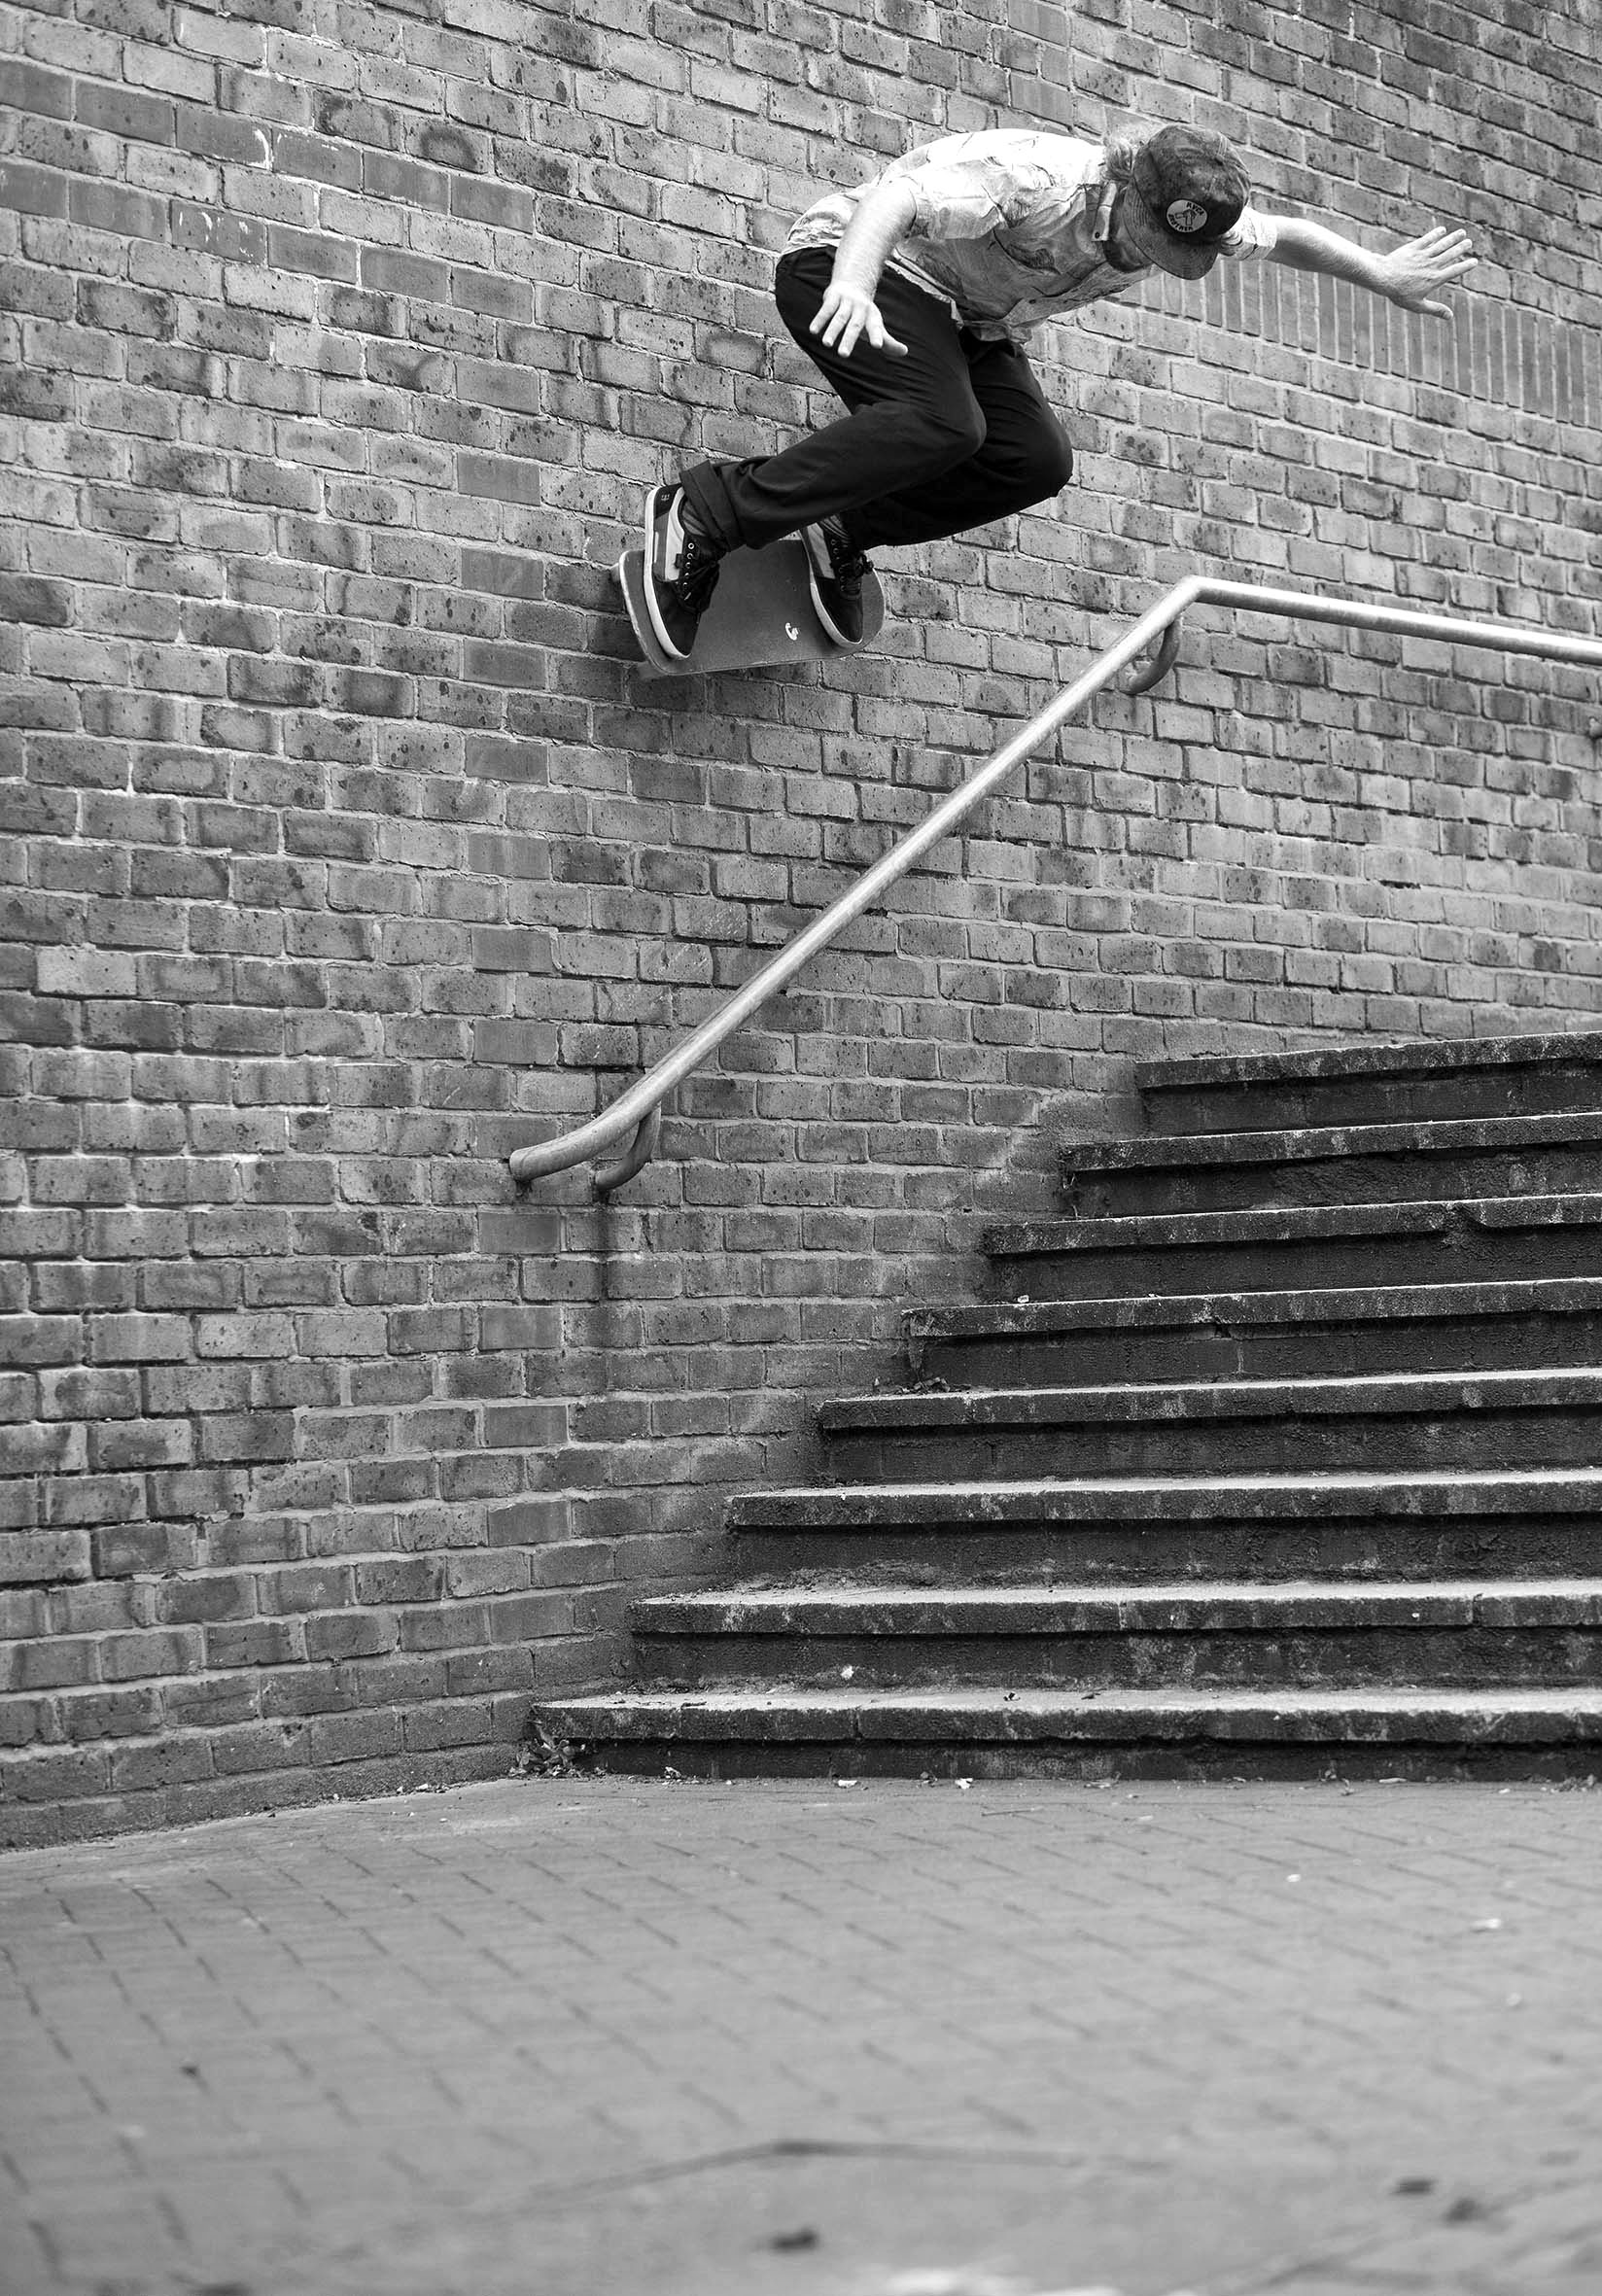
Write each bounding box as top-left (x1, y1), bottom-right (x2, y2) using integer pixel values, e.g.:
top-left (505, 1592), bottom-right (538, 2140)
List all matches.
top-left (0, 0), bottom-right (1602, 1839)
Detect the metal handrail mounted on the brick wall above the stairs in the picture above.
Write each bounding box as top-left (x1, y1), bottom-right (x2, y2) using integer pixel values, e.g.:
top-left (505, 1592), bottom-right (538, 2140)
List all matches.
top-left (507, 574), bottom-right (1602, 1197)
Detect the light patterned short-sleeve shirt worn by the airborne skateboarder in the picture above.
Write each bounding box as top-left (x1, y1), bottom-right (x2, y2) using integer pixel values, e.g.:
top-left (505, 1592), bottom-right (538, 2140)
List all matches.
top-left (784, 128), bottom-right (1273, 340)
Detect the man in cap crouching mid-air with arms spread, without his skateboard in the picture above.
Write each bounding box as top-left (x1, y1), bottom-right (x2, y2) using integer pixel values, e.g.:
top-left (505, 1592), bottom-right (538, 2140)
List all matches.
top-left (644, 126), bottom-right (1474, 661)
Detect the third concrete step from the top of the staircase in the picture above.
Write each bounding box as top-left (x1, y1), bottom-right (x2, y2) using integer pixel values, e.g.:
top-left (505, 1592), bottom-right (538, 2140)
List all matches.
top-left (983, 1194), bottom-right (1602, 1300)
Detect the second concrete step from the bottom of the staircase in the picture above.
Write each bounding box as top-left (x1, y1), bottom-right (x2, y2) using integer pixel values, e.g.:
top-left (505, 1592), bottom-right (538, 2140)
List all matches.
top-left (629, 1578), bottom-right (1602, 1689)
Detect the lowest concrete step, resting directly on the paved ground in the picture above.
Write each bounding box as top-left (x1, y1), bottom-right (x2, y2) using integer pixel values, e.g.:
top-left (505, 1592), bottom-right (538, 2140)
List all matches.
top-left (540, 1686), bottom-right (1602, 1780)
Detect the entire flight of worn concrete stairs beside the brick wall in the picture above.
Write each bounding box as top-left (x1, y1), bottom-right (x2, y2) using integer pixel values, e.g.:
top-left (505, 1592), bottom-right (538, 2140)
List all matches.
top-left (541, 1031), bottom-right (1602, 1777)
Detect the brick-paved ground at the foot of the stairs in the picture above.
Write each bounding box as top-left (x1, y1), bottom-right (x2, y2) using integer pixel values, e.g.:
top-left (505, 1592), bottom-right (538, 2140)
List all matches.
top-left (0, 1780), bottom-right (1602, 2296)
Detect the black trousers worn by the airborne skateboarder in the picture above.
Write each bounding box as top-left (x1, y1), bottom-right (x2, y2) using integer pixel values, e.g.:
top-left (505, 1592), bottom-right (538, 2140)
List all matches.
top-left (681, 248), bottom-right (1074, 551)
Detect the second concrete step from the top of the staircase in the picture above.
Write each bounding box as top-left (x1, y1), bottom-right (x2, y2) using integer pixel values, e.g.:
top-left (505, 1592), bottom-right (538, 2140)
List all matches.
top-left (1061, 1111), bottom-right (1602, 1219)
